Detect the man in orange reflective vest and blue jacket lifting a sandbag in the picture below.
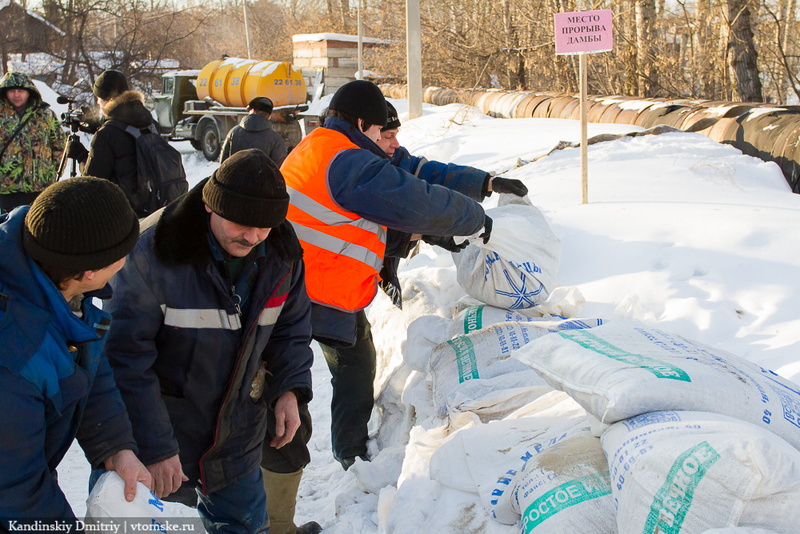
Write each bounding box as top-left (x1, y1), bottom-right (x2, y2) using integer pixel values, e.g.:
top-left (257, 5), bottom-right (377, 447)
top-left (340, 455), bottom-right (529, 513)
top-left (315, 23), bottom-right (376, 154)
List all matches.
top-left (281, 80), bottom-right (491, 478)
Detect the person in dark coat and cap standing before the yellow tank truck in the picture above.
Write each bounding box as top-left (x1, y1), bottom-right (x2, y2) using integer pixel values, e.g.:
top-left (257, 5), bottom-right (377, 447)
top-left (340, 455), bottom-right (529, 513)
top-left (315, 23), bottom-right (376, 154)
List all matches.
top-left (219, 96), bottom-right (286, 167)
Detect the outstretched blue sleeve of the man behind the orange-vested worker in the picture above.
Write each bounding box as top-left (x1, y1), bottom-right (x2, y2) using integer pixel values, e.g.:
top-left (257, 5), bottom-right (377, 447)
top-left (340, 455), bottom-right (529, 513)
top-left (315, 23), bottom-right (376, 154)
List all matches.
top-left (392, 147), bottom-right (489, 202)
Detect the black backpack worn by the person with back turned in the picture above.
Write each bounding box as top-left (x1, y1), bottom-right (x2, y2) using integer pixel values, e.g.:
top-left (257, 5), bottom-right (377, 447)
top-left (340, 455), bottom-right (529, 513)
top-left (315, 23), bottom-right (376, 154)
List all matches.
top-left (108, 120), bottom-right (189, 217)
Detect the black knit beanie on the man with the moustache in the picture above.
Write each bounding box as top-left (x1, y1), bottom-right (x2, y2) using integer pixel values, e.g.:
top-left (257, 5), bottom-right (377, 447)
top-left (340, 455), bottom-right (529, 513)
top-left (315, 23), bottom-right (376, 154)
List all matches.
top-left (203, 148), bottom-right (289, 228)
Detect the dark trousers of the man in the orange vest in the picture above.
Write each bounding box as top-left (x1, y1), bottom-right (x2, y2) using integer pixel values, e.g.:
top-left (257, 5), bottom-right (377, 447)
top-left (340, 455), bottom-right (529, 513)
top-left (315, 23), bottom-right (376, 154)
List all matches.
top-left (320, 310), bottom-right (376, 460)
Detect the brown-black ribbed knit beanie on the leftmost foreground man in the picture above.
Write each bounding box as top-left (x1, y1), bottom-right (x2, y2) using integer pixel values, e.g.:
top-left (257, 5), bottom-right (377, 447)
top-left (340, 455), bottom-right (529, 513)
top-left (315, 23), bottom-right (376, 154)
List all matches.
top-left (22, 176), bottom-right (139, 272)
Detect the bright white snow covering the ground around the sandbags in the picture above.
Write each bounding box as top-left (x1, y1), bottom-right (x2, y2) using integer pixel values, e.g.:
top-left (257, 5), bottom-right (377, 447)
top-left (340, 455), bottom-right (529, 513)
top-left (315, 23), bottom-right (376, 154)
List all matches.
top-left (59, 100), bottom-right (800, 534)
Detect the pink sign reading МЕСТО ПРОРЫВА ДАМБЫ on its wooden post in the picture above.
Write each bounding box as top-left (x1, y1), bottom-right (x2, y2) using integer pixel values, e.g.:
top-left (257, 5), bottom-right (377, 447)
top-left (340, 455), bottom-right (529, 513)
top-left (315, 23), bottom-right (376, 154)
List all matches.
top-left (555, 9), bottom-right (614, 204)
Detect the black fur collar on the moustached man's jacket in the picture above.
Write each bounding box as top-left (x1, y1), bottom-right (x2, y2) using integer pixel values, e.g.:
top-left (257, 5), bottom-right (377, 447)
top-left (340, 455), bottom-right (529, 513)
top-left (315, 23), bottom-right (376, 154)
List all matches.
top-left (152, 178), bottom-right (303, 265)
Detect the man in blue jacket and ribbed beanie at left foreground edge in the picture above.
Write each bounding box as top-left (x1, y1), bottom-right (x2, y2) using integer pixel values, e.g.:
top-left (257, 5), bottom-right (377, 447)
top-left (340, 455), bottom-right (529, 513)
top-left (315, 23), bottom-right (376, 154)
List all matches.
top-left (0, 177), bottom-right (151, 531)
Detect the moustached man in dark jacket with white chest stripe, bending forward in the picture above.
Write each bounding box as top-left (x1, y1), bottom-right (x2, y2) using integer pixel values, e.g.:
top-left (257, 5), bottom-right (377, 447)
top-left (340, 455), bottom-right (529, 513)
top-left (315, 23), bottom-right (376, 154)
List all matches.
top-left (107, 149), bottom-right (318, 533)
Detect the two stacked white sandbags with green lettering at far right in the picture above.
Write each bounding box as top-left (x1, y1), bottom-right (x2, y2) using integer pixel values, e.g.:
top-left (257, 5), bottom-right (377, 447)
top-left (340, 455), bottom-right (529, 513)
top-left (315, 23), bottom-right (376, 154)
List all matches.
top-left (506, 321), bottom-right (800, 534)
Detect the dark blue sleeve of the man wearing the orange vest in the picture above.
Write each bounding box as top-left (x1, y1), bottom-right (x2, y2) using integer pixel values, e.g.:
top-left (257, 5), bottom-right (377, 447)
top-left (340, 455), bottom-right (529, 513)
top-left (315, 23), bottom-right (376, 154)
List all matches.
top-left (328, 149), bottom-right (484, 236)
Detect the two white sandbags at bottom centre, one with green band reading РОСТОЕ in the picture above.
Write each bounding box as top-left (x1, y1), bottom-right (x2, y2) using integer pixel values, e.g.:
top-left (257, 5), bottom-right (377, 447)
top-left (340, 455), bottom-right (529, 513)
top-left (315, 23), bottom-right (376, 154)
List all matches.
top-left (431, 391), bottom-right (616, 534)
